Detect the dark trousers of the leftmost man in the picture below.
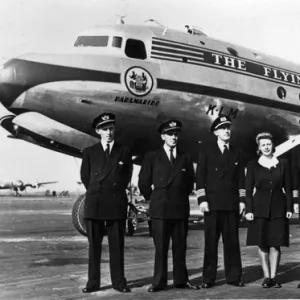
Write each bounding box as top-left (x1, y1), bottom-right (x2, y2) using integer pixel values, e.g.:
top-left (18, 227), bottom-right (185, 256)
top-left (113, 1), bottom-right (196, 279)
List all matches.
top-left (86, 219), bottom-right (127, 288)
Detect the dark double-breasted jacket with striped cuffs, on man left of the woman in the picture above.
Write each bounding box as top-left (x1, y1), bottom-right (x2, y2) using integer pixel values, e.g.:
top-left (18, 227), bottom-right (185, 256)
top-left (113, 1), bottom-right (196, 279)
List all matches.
top-left (196, 142), bottom-right (245, 210)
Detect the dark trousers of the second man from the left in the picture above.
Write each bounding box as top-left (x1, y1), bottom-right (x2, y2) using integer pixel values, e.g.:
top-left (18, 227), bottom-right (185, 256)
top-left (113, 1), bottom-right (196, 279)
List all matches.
top-left (151, 218), bottom-right (188, 287)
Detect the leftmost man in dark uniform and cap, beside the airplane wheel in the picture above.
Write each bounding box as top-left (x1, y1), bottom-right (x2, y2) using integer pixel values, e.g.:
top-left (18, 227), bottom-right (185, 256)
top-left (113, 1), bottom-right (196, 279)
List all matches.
top-left (81, 113), bottom-right (132, 293)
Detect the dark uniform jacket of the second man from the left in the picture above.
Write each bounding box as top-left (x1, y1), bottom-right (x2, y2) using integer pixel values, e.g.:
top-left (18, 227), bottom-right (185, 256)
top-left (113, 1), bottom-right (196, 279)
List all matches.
top-left (139, 148), bottom-right (195, 219)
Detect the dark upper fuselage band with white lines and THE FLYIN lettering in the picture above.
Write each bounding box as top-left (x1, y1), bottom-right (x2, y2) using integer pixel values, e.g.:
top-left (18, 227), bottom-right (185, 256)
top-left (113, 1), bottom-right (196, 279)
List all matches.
top-left (151, 38), bottom-right (300, 89)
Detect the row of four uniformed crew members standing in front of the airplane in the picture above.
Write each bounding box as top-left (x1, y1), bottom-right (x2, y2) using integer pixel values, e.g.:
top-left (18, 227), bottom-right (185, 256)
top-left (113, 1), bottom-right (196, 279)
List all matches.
top-left (81, 113), bottom-right (298, 293)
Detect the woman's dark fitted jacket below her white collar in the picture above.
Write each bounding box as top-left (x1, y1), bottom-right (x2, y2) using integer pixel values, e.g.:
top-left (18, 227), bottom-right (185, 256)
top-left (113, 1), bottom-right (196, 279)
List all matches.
top-left (246, 159), bottom-right (293, 218)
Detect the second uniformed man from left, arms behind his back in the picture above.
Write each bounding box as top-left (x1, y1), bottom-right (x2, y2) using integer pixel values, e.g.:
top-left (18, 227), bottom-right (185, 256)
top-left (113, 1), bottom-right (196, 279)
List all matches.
top-left (139, 120), bottom-right (199, 292)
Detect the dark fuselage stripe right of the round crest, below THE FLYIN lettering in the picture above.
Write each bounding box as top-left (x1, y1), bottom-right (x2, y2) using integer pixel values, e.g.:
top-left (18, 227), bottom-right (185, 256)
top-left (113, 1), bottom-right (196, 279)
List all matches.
top-left (157, 78), bottom-right (300, 113)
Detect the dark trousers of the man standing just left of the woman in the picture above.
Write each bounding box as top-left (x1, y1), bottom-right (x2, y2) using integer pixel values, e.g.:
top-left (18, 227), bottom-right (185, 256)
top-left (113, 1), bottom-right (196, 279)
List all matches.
top-left (203, 211), bottom-right (242, 283)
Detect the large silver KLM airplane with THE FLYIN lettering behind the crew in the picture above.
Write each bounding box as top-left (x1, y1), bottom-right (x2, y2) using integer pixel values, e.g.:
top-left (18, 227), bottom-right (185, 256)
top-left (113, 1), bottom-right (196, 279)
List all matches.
top-left (0, 19), bottom-right (300, 234)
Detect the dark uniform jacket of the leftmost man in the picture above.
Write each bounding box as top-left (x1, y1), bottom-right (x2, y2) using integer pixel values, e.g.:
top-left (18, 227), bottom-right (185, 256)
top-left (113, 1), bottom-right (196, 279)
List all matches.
top-left (81, 142), bottom-right (132, 220)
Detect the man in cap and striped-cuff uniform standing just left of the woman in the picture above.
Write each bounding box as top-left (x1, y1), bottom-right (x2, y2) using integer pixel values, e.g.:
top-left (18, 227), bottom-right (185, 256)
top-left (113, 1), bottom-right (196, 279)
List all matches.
top-left (196, 115), bottom-right (245, 288)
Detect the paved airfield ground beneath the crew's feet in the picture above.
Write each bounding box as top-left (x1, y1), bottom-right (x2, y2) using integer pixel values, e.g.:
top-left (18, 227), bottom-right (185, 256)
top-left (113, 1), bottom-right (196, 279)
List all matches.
top-left (0, 197), bottom-right (300, 300)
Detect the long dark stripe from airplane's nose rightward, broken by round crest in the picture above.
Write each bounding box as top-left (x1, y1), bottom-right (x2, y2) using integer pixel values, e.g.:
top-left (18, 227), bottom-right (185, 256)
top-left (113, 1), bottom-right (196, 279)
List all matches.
top-left (0, 59), bottom-right (300, 113)
